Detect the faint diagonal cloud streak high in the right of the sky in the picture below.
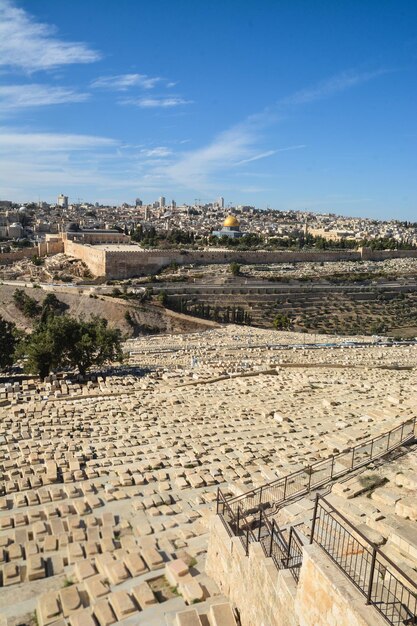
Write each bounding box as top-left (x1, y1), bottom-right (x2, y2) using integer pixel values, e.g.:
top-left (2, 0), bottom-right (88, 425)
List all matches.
top-left (278, 69), bottom-right (389, 105)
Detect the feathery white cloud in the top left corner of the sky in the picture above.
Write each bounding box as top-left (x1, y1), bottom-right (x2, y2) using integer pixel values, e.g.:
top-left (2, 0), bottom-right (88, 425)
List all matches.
top-left (0, 0), bottom-right (101, 71)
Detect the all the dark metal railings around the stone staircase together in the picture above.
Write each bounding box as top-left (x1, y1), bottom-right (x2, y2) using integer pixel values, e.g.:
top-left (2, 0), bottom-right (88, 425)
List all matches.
top-left (217, 417), bottom-right (417, 626)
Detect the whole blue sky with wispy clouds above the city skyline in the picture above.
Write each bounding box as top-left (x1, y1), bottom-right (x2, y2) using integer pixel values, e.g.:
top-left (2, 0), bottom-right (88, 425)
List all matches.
top-left (0, 0), bottom-right (417, 221)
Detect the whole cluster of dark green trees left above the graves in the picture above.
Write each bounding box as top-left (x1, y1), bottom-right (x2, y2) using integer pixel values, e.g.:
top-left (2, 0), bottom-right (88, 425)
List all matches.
top-left (0, 290), bottom-right (123, 378)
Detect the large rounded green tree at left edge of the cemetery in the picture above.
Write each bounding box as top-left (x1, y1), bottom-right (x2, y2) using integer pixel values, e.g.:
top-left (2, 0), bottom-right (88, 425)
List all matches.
top-left (22, 315), bottom-right (123, 378)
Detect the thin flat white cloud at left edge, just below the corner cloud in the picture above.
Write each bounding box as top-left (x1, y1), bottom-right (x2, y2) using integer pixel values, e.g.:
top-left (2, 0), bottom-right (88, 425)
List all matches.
top-left (0, 84), bottom-right (89, 110)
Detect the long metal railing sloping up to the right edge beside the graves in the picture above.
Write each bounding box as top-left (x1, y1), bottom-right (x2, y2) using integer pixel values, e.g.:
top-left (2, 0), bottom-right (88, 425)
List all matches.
top-left (217, 417), bottom-right (416, 517)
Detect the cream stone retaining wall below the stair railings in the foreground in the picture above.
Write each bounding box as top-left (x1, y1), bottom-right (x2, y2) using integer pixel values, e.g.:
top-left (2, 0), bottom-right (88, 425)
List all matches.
top-left (206, 516), bottom-right (386, 626)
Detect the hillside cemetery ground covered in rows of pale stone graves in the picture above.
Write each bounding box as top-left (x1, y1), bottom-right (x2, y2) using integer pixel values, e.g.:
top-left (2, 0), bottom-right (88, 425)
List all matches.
top-left (0, 326), bottom-right (417, 626)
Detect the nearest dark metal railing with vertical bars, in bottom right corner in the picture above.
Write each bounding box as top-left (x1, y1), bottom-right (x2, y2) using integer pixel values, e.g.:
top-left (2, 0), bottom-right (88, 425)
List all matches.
top-left (310, 494), bottom-right (417, 626)
